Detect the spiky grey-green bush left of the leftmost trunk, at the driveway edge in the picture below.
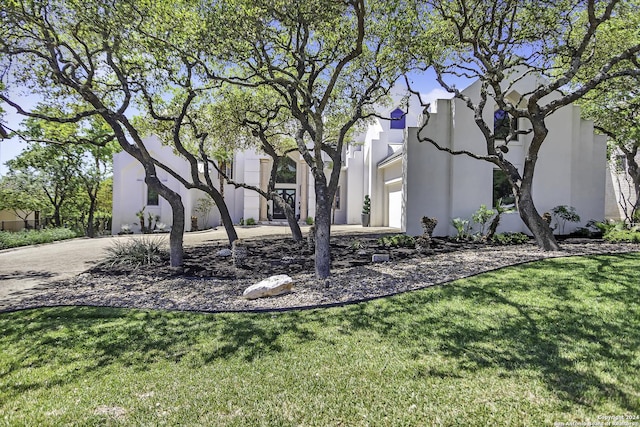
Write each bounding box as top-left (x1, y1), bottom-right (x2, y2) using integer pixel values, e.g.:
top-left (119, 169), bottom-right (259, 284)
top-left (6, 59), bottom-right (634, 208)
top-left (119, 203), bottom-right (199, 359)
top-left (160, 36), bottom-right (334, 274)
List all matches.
top-left (105, 236), bottom-right (167, 267)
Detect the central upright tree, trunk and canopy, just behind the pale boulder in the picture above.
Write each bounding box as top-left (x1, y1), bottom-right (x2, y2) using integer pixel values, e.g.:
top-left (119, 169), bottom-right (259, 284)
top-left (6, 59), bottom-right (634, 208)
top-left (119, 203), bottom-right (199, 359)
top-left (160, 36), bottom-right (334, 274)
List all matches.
top-left (212, 0), bottom-right (410, 279)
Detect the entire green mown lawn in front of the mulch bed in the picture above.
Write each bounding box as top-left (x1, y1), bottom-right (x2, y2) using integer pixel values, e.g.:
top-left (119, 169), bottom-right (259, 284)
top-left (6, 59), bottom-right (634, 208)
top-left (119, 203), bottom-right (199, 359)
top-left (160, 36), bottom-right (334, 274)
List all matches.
top-left (0, 254), bottom-right (640, 426)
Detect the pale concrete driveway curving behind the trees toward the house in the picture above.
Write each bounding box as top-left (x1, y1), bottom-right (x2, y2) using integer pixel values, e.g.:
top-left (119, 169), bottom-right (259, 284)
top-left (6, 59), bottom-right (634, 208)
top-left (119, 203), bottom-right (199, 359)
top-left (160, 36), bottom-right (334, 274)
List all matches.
top-left (0, 225), bottom-right (392, 308)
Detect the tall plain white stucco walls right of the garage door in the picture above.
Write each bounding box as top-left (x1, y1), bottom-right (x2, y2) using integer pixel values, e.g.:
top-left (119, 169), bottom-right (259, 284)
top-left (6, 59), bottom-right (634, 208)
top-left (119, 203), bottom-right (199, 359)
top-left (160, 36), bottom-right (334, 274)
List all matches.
top-left (403, 75), bottom-right (606, 239)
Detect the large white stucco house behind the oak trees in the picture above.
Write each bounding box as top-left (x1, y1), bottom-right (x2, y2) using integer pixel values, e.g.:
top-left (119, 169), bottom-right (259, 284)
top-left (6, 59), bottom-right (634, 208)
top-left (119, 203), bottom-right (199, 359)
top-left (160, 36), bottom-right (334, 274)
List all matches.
top-left (113, 78), bottom-right (607, 239)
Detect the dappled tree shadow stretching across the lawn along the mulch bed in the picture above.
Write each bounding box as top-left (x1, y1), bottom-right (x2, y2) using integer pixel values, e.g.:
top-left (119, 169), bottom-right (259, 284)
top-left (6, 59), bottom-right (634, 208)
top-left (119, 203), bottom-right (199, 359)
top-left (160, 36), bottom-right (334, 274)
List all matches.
top-left (0, 254), bottom-right (640, 413)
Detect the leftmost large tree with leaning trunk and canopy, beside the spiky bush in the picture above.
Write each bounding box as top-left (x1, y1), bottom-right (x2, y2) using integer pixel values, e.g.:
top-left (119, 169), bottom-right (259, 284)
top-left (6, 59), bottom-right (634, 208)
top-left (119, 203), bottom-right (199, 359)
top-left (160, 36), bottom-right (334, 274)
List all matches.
top-left (0, 0), bottom-right (208, 266)
